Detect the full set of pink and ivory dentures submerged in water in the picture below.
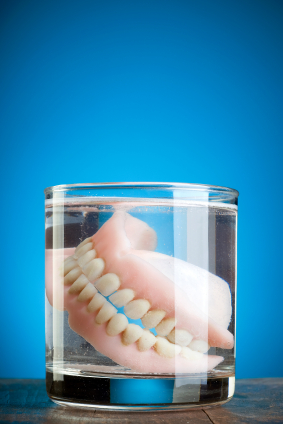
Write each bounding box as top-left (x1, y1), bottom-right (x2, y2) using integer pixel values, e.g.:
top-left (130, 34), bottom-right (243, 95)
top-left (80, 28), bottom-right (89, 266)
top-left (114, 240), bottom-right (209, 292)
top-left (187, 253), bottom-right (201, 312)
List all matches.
top-left (46, 211), bottom-right (233, 373)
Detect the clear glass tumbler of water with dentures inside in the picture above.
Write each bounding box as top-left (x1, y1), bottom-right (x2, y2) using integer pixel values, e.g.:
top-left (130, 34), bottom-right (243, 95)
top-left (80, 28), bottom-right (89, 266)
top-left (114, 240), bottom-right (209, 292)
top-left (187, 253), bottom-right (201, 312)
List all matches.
top-left (45, 183), bottom-right (239, 411)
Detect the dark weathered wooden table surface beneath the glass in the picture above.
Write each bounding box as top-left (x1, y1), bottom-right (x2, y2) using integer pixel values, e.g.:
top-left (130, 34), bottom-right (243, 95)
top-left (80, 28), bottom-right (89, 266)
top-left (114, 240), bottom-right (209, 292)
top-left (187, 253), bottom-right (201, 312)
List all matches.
top-left (0, 378), bottom-right (283, 424)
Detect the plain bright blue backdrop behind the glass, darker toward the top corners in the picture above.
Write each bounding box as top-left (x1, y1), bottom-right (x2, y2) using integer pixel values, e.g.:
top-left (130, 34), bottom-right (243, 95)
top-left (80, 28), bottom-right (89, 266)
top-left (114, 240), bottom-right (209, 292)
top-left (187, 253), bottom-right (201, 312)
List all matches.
top-left (0, 0), bottom-right (283, 378)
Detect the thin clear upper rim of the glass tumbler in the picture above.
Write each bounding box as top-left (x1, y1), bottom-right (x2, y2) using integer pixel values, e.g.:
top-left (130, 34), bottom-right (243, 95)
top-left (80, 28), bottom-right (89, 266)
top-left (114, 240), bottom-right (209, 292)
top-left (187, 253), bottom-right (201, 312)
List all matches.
top-left (44, 182), bottom-right (239, 197)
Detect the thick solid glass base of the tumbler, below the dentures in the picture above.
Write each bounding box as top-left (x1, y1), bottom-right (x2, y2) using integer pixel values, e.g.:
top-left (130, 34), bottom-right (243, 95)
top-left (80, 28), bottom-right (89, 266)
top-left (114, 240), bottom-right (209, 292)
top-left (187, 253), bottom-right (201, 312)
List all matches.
top-left (46, 370), bottom-right (235, 412)
